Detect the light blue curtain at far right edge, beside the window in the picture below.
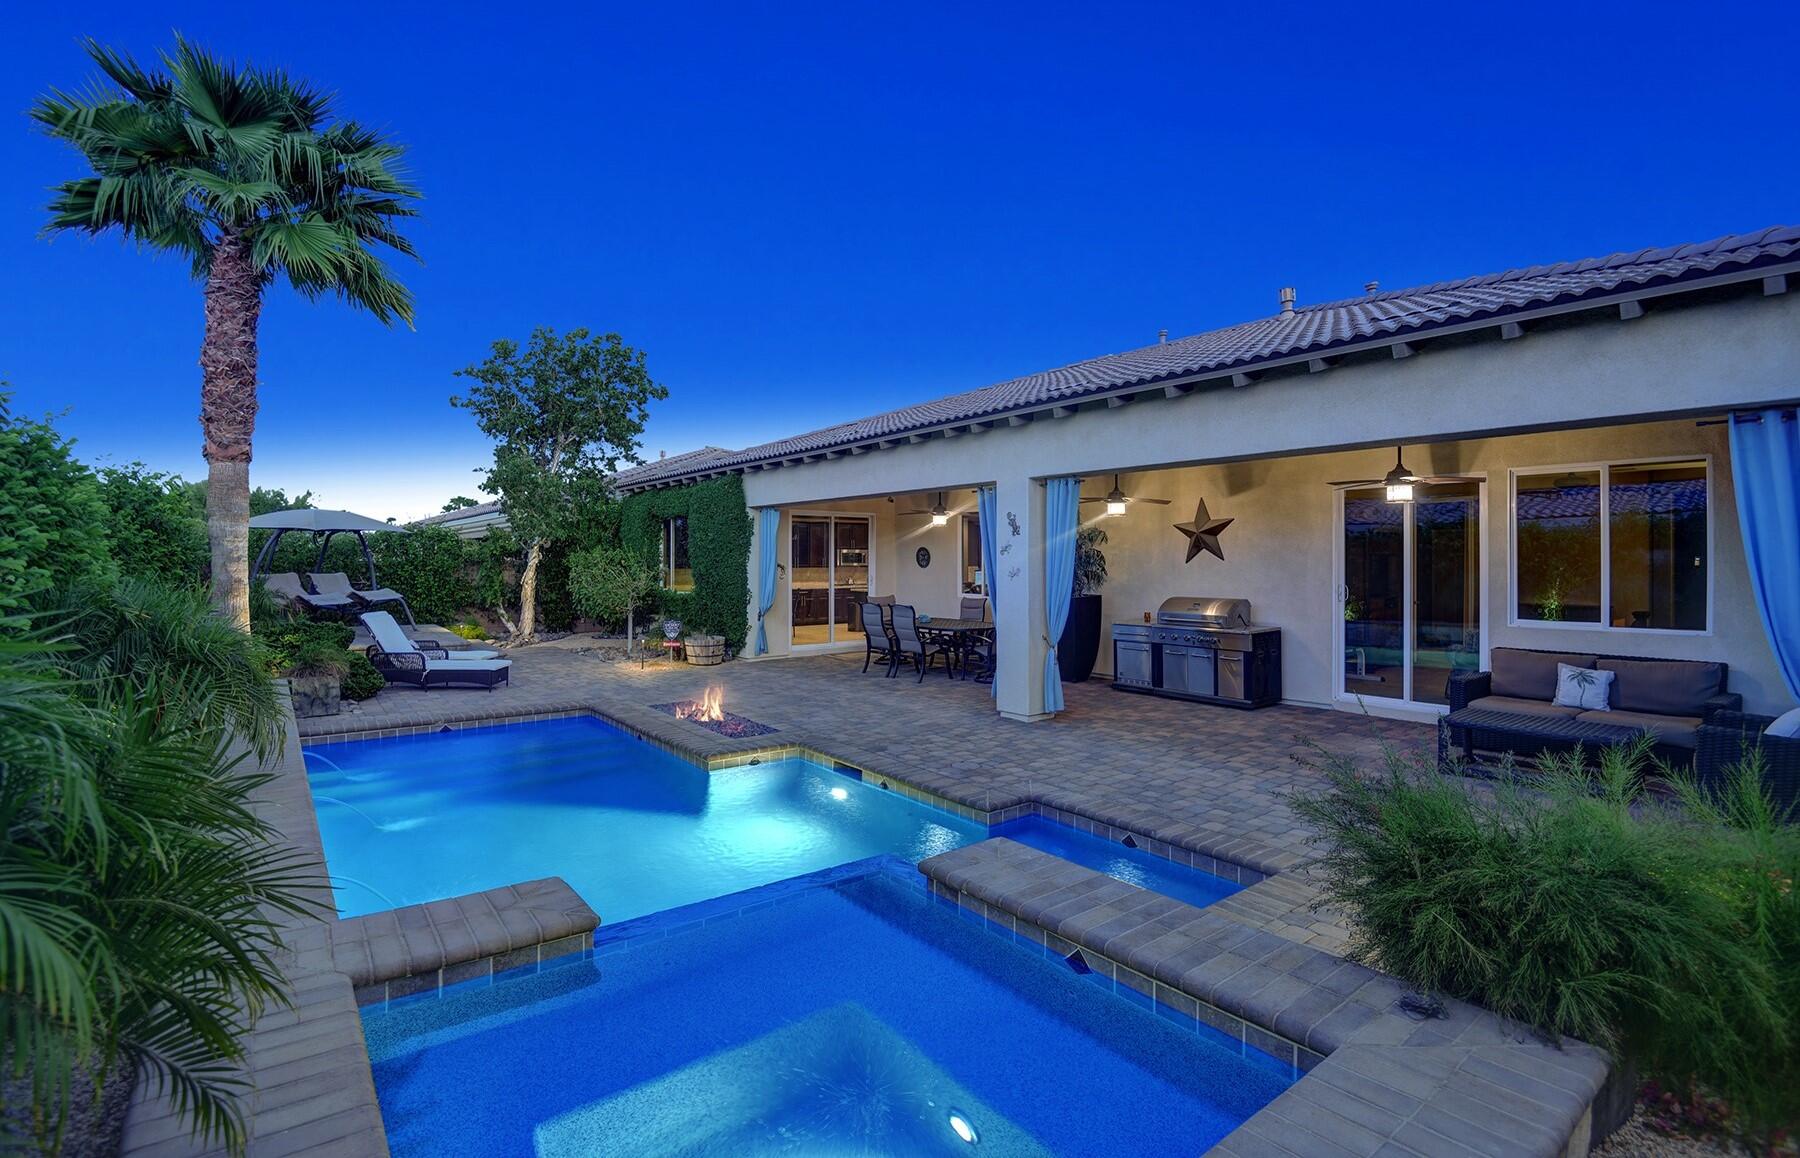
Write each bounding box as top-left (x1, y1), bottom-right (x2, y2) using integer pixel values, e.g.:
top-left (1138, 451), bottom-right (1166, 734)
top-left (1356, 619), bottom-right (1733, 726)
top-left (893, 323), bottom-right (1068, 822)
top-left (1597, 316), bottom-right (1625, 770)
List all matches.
top-left (1730, 411), bottom-right (1800, 699)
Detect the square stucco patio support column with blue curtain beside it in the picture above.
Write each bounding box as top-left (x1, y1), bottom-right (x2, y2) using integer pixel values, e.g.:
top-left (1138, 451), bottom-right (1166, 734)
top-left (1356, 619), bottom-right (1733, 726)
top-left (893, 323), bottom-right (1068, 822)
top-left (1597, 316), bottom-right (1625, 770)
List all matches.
top-left (983, 477), bottom-right (1051, 720)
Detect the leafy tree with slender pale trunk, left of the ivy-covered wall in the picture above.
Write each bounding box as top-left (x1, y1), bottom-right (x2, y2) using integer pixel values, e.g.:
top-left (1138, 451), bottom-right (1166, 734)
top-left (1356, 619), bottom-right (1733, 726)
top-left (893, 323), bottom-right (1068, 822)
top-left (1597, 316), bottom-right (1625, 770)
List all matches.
top-left (450, 326), bottom-right (668, 638)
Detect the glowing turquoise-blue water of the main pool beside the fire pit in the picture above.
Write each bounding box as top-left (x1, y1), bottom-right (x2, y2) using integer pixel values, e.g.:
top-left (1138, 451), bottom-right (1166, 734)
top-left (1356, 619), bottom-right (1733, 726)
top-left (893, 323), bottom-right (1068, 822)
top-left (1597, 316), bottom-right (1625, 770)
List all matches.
top-left (306, 717), bottom-right (988, 924)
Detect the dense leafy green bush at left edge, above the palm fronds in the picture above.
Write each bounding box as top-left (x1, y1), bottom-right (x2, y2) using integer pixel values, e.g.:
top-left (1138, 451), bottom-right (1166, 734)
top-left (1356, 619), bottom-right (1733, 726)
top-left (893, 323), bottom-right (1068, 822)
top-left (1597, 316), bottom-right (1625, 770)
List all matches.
top-left (0, 394), bottom-right (113, 616)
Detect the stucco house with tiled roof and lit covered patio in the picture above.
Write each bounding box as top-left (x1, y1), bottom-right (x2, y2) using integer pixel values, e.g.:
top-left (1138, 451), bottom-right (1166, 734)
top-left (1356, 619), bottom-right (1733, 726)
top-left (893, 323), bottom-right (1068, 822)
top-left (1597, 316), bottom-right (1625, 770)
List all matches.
top-left (617, 227), bottom-right (1800, 719)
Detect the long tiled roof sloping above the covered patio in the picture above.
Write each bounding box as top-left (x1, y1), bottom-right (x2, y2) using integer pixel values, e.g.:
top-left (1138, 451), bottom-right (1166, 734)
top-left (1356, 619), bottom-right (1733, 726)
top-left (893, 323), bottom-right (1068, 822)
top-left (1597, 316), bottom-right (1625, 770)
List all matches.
top-left (617, 225), bottom-right (1800, 490)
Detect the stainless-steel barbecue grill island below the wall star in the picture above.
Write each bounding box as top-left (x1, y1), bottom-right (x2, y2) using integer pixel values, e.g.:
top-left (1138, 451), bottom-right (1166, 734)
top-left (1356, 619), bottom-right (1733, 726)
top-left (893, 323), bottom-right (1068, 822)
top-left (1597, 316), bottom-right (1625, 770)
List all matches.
top-left (1112, 596), bottom-right (1282, 708)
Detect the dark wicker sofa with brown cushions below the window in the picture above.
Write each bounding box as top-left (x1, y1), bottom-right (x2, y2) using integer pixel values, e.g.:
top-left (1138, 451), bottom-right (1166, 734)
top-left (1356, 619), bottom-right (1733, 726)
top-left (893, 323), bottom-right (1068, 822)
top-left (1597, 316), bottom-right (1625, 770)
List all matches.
top-left (1445, 647), bottom-right (1744, 767)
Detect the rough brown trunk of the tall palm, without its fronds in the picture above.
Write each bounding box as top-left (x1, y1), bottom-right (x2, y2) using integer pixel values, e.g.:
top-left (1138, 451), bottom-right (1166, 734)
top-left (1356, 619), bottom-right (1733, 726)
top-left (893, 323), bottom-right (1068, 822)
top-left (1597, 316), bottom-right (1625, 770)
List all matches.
top-left (200, 232), bottom-right (263, 630)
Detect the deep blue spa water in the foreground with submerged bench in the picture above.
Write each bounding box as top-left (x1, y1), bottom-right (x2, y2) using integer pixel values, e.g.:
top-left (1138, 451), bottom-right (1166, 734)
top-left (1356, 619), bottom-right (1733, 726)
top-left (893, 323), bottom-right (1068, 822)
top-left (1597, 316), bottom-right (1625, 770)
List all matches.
top-left (364, 857), bottom-right (1294, 1158)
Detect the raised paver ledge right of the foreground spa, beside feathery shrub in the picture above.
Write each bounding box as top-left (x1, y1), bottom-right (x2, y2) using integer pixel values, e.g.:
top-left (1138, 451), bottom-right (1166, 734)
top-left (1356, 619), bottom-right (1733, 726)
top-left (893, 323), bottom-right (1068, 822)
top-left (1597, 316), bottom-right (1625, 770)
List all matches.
top-left (920, 837), bottom-right (1609, 1158)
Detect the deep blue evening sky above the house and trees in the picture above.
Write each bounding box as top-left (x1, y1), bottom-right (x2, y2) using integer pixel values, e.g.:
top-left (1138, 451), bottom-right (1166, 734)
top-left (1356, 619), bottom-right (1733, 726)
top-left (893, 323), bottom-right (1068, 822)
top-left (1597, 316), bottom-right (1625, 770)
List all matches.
top-left (0, 0), bottom-right (1800, 517)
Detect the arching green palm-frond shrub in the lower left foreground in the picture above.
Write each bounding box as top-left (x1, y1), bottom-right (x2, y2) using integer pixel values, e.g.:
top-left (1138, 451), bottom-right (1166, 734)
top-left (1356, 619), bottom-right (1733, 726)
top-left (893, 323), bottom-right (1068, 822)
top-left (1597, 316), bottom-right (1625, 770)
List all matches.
top-left (0, 580), bottom-right (322, 1149)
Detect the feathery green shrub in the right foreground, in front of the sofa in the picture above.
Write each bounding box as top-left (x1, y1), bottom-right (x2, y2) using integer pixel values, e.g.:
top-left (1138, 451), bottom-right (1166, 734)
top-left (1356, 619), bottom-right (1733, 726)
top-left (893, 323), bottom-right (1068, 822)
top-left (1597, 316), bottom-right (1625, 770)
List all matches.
top-left (1292, 742), bottom-right (1800, 1129)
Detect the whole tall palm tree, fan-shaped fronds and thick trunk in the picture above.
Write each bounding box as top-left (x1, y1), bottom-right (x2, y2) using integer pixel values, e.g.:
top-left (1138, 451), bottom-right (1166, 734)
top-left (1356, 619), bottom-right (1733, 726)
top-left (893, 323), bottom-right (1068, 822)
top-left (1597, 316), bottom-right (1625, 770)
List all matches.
top-left (31, 38), bottom-right (418, 629)
